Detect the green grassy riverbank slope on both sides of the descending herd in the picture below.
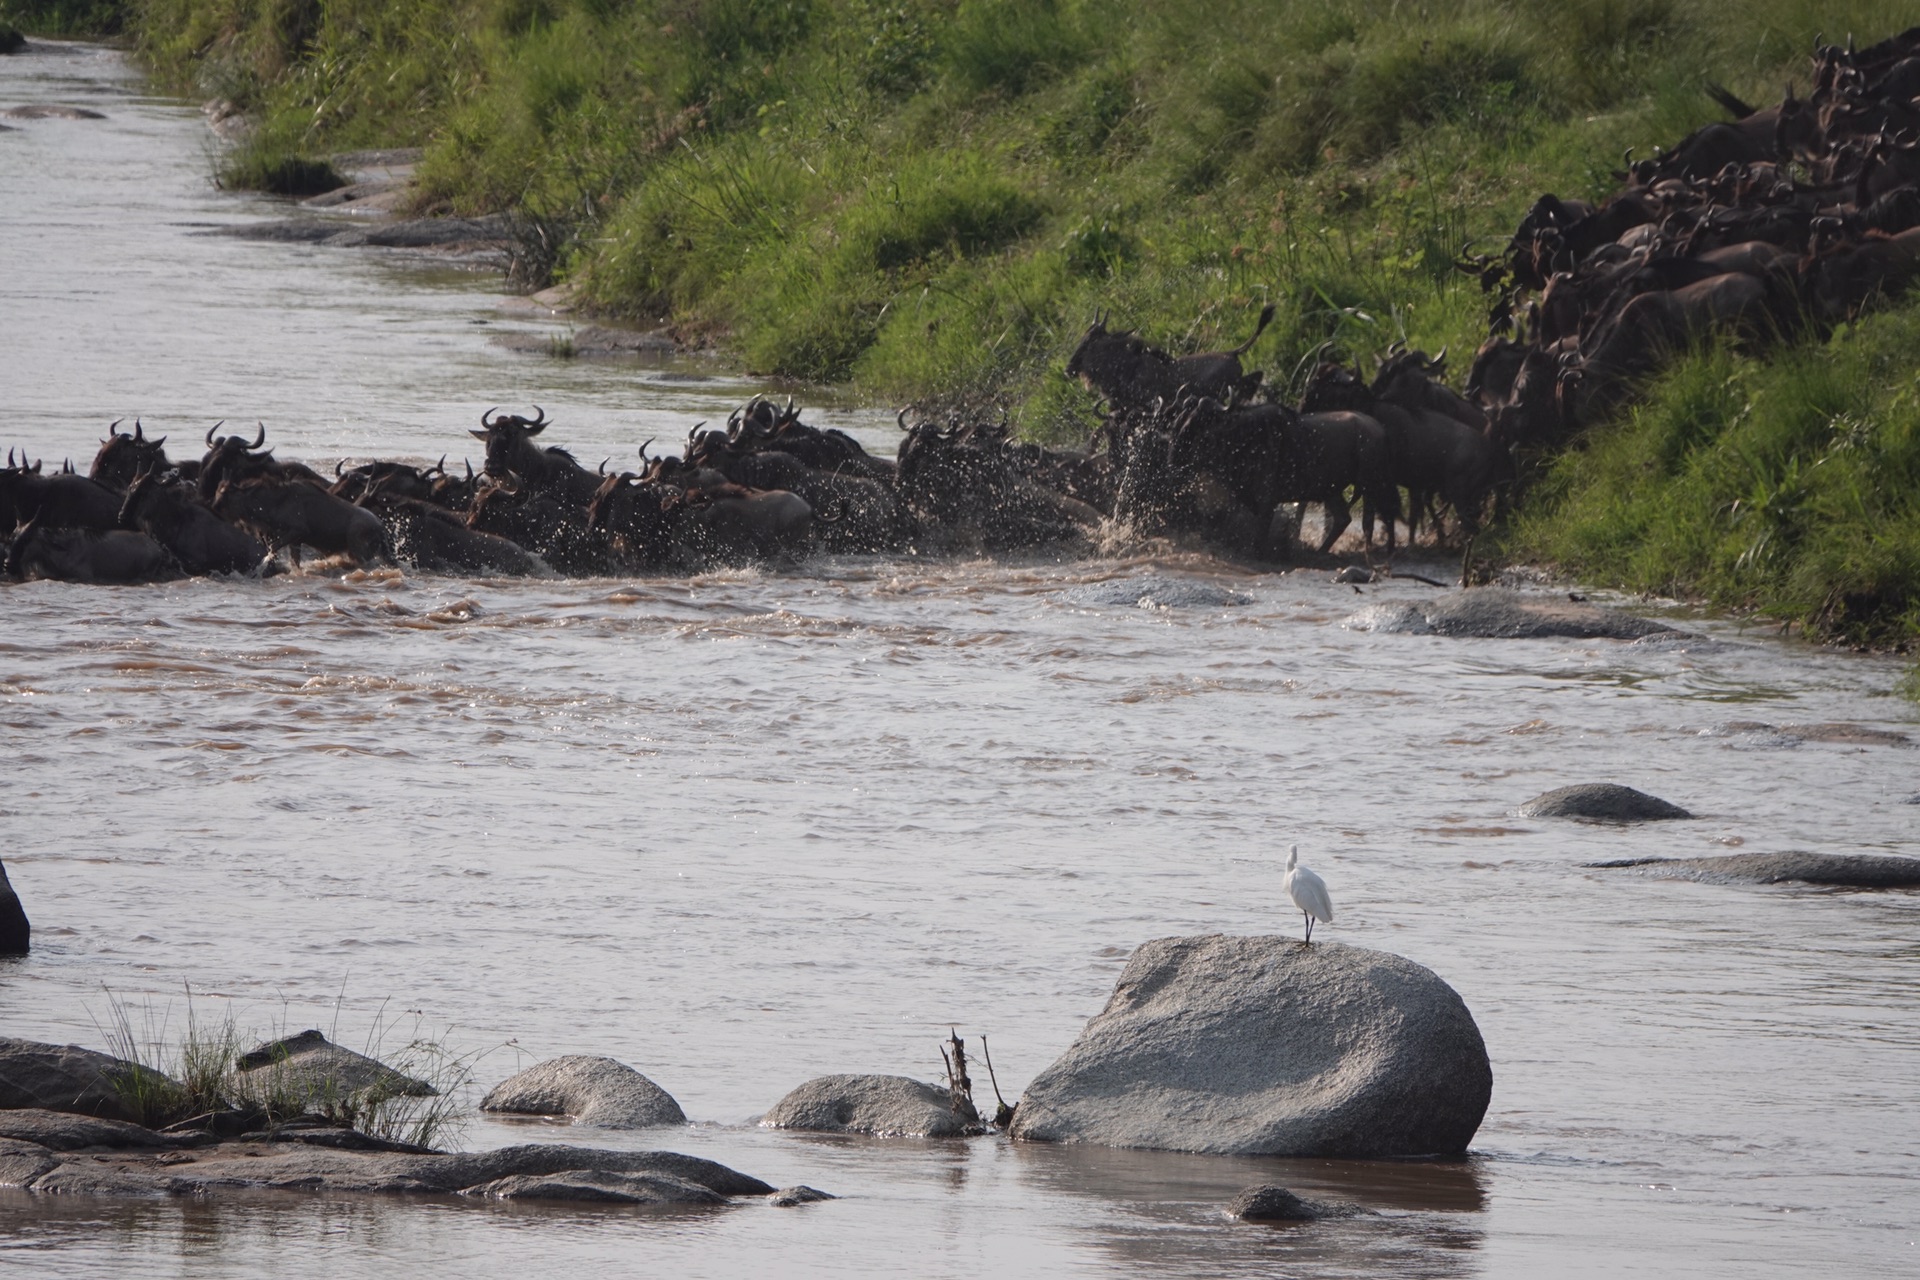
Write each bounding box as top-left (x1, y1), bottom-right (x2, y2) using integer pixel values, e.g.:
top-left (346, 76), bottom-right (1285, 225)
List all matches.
top-left (11, 0), bottom-right (1920, 660)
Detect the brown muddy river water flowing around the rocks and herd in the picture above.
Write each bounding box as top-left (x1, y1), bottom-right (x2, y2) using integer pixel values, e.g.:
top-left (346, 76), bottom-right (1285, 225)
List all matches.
top-left (0, 35), bottom-right (1920, 1278)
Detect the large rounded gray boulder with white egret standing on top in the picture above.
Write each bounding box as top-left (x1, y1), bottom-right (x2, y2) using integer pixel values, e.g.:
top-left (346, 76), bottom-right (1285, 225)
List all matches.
top-left (1012, 935), bottom-right (1494, 1159)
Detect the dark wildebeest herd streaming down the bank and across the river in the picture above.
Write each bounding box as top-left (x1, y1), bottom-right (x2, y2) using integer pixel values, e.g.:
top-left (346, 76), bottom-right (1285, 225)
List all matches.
top-left (11, 27), bottom-right (1920, 583)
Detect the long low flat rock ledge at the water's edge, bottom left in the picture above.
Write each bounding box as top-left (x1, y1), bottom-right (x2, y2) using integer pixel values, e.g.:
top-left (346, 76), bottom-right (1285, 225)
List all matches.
top-left (0, 1134), bottom-right (774, 1205)
